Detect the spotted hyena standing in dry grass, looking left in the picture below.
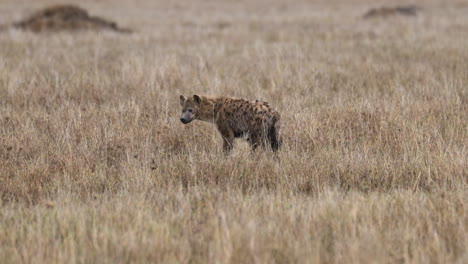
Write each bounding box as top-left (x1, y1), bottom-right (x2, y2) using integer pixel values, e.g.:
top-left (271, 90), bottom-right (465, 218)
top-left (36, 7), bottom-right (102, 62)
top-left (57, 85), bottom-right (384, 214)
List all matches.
top-left (180, 95), bottom-right (281, 153)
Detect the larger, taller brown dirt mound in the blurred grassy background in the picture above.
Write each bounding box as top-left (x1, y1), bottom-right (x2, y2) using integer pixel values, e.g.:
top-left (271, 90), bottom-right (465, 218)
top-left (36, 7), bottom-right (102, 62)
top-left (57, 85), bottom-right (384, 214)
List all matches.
top-left (13, 5), bottom-right (131, 33)
